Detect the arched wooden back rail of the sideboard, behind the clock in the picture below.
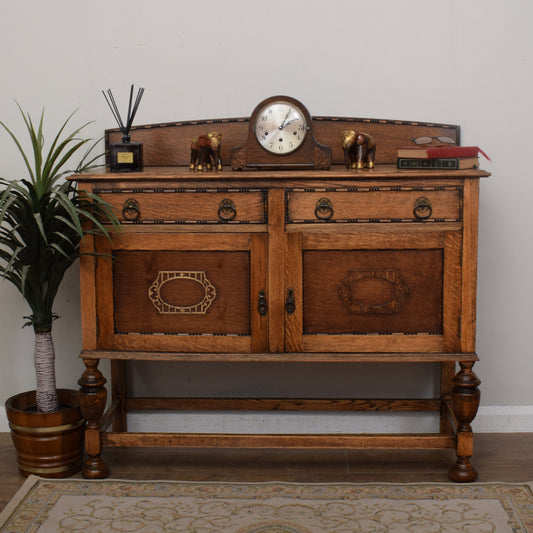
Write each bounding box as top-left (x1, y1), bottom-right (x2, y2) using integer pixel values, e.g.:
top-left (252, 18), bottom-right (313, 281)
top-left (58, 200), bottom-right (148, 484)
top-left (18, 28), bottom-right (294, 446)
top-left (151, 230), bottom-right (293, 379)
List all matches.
top-left (105, 117), bottom-right (460, 167)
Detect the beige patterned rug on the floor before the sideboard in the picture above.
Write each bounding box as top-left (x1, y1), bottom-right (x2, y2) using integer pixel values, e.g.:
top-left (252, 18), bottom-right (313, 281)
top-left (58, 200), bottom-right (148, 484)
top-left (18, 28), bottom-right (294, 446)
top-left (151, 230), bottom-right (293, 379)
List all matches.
top-left (0, 476), bottom-right (533, 533)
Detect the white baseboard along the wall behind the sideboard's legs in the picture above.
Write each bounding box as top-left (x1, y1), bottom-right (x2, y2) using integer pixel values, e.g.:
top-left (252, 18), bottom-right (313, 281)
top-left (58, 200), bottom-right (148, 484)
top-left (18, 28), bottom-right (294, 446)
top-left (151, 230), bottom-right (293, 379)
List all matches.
top-left (0, 405), bottom-right (533, 433)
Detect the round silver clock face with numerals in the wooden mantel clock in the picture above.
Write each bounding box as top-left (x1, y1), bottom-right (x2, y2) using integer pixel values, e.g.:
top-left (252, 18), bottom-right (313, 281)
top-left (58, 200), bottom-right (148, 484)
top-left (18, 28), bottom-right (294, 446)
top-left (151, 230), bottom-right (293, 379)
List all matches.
top-left (254, 100), bottom-right (309, 155)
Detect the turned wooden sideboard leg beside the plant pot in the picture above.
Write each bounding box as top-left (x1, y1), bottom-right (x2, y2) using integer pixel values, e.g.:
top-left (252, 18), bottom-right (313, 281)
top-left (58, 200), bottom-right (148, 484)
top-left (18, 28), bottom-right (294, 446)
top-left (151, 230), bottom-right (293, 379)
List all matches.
top-left (78, 359), bottom-right (109, 479)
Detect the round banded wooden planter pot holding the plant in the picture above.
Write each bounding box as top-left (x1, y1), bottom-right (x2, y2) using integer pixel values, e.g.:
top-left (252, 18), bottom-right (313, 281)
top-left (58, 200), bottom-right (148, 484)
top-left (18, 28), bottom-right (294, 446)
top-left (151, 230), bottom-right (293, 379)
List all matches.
top-left (5, 389), bottom-right (85, 478)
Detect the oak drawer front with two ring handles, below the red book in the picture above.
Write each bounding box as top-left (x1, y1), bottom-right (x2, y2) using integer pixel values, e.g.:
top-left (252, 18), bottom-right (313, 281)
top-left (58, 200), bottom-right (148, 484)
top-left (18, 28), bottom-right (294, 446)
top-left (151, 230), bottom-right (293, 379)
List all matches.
top-left (286, 186), bottom-right (462, 224)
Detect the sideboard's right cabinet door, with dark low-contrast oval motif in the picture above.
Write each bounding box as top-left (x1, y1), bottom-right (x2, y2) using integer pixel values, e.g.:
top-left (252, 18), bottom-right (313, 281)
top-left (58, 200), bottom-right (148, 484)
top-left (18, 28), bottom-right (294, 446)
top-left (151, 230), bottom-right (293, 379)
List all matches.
top-left (285, 229), bottom-right (461, 353)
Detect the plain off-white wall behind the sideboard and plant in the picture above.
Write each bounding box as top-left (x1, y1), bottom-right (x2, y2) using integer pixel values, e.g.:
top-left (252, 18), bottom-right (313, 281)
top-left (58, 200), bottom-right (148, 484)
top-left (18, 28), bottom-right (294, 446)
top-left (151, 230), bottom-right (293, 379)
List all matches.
top-left (0, 0), bottom-right (533, 431)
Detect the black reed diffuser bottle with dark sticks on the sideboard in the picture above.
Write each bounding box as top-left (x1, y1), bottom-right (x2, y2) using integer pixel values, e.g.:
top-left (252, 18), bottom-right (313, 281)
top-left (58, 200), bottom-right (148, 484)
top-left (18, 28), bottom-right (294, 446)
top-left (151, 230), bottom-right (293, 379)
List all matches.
top-left (102, 85), bottom-right (144, 172)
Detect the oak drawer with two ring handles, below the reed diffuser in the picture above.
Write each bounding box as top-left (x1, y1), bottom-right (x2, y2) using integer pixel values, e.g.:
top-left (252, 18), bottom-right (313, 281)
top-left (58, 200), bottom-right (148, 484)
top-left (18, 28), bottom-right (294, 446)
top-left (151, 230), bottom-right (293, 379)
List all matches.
top-left (94, 188), bottom-right (267, 224)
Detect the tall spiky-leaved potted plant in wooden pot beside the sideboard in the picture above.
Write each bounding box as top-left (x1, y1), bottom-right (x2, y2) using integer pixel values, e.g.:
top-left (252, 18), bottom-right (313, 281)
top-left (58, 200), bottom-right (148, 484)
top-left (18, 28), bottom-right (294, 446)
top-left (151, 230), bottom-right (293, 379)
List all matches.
top-left (0, 106), bottom-right (118, 477)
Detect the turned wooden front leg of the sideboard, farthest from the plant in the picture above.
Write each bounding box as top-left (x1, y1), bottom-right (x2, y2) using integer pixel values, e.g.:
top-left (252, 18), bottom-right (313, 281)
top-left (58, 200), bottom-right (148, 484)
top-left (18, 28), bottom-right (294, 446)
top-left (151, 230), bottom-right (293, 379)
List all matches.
top-left (449, 363), bottom-right (481, 483)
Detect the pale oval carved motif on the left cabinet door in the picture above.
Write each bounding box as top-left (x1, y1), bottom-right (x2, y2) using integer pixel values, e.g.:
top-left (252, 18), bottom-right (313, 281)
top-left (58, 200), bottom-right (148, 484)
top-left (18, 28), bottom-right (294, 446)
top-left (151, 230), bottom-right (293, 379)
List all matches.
top-left (148, 270), bottom-right (217, 315)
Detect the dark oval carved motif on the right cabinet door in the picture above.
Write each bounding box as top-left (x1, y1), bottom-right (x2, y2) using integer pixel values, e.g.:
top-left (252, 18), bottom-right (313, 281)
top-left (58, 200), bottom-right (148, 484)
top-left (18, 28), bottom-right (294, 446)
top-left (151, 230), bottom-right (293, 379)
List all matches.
top-left (338, 268), bottom-right (409, 314)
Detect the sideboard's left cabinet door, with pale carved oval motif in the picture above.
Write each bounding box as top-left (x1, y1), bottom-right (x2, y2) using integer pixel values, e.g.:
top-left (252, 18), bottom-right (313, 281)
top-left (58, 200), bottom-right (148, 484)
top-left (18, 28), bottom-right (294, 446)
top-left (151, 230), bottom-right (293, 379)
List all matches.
top-left (96, 232), bottom-right (267, 353)
